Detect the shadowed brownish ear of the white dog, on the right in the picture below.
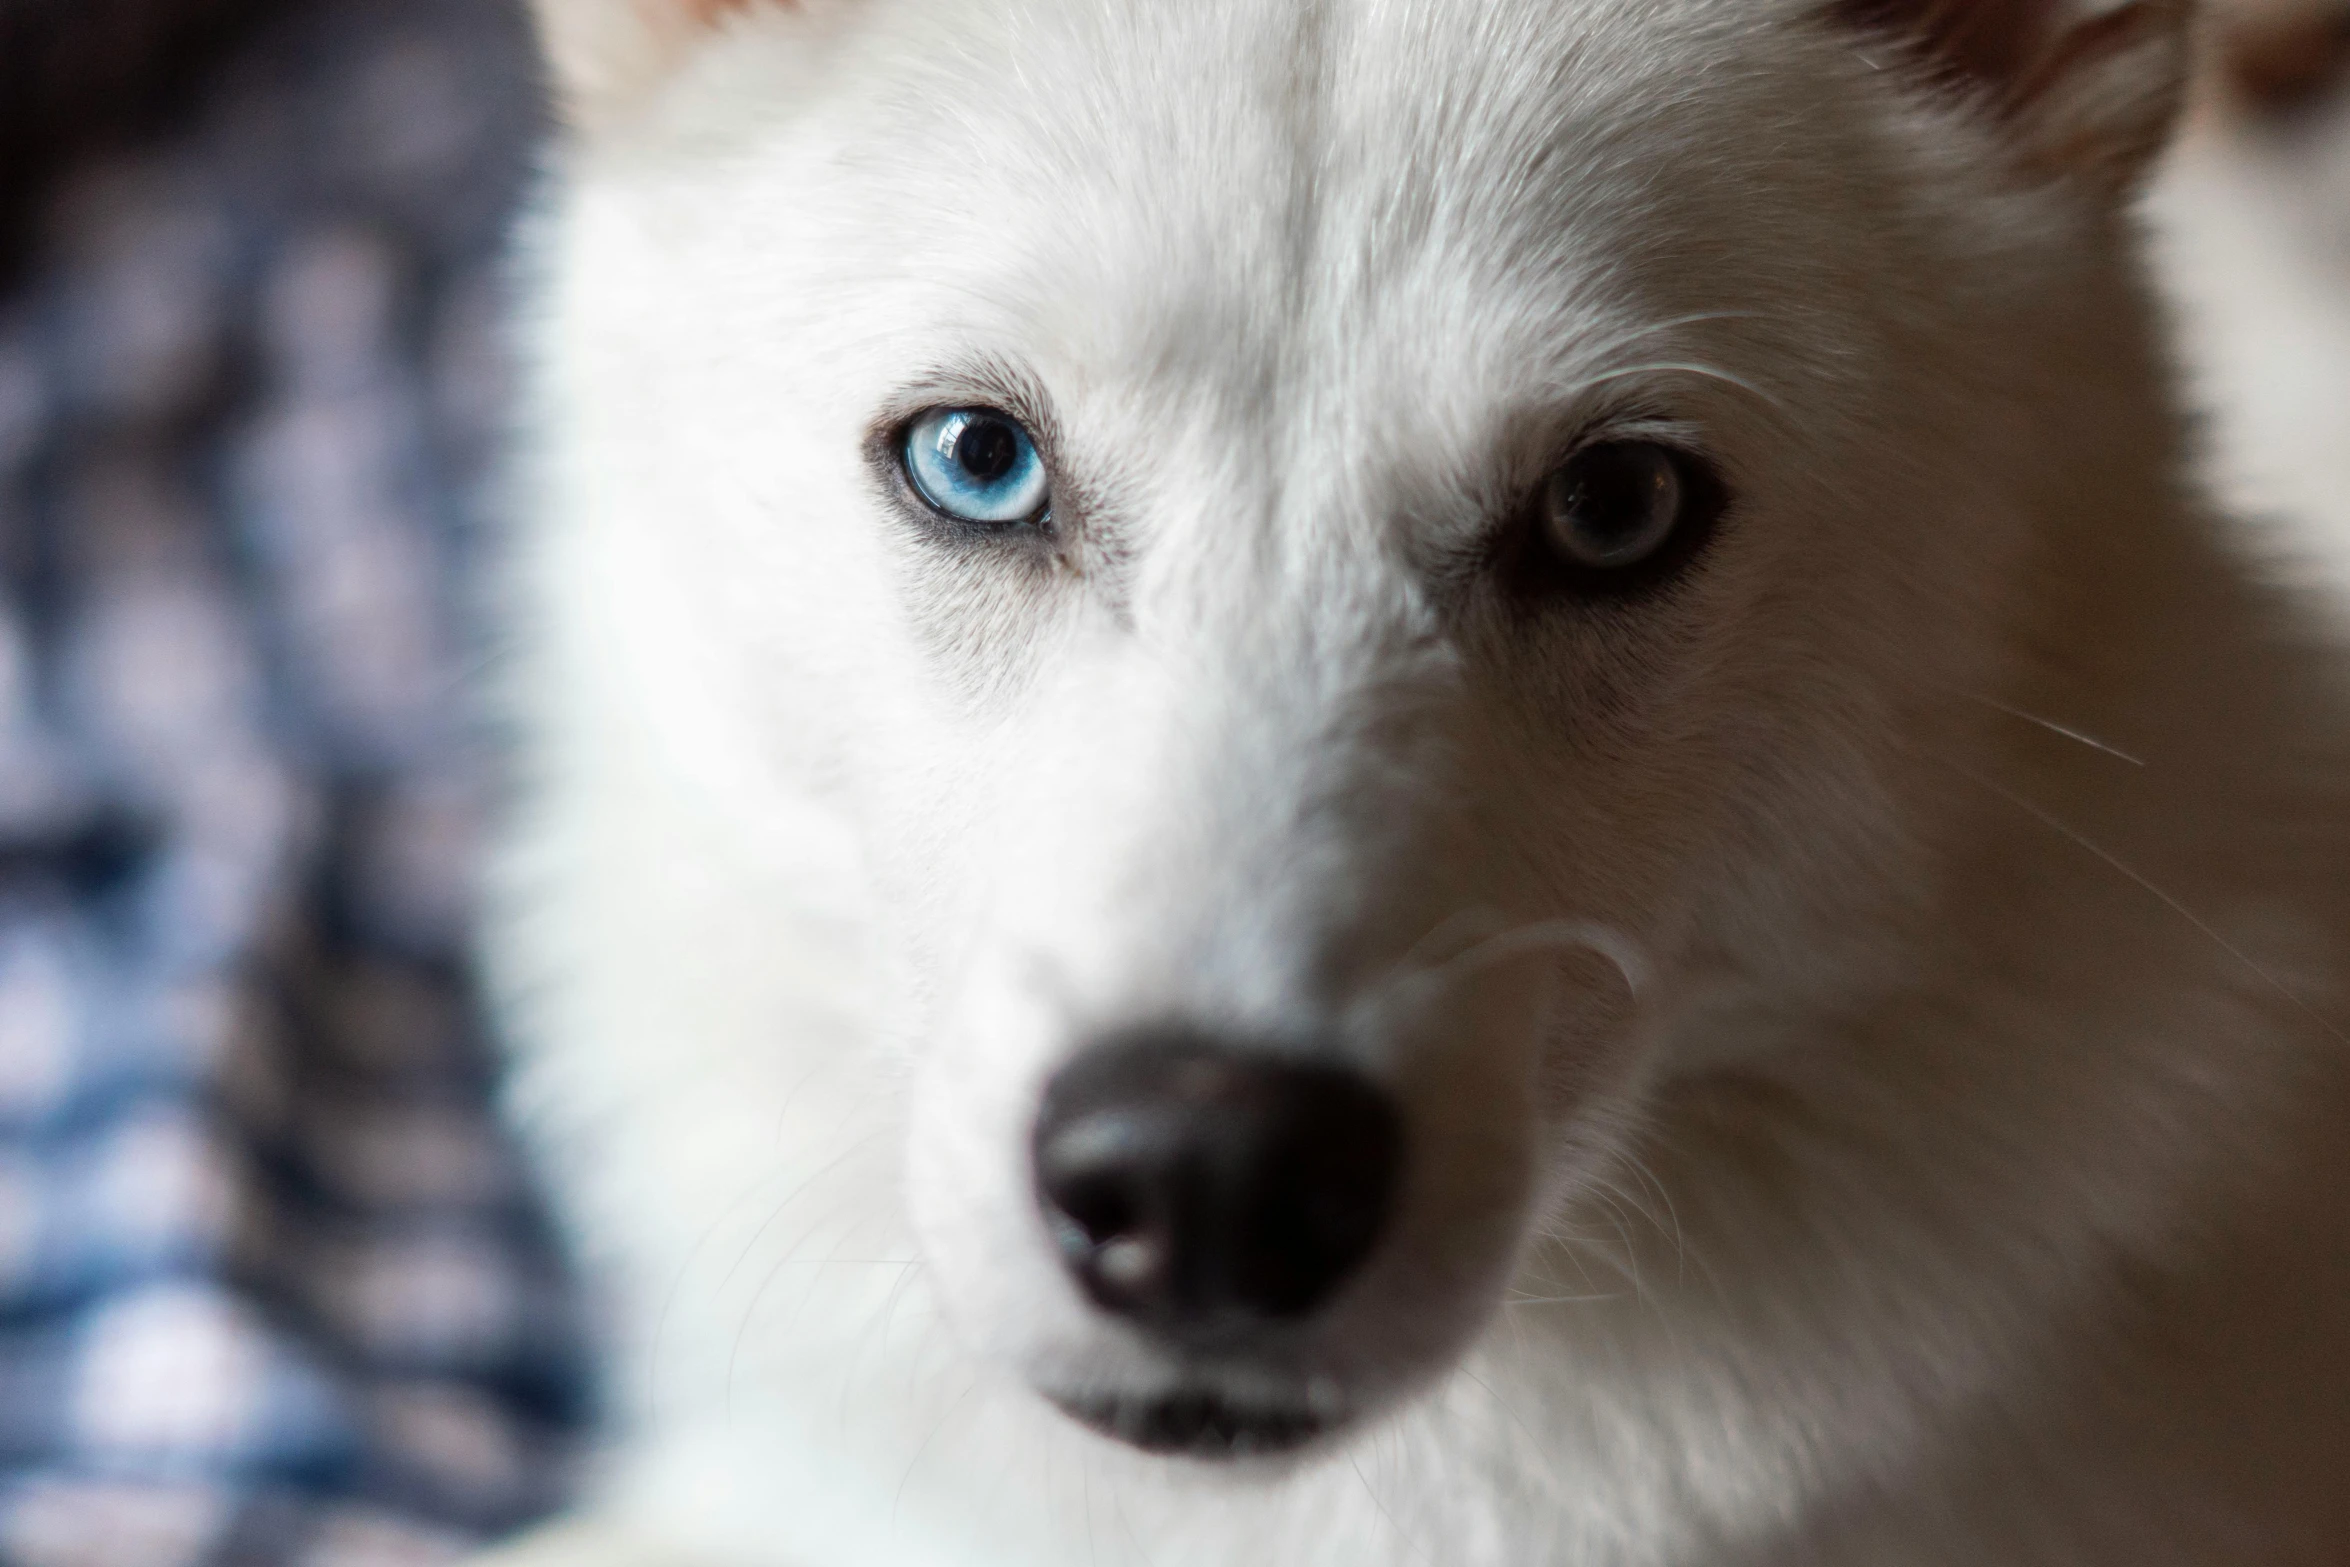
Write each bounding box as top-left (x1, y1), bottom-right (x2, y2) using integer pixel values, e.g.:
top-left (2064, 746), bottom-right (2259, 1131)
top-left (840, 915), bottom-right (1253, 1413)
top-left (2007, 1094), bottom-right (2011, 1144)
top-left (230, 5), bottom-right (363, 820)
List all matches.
top-left (1833, 0), bottom-right (2195, 190)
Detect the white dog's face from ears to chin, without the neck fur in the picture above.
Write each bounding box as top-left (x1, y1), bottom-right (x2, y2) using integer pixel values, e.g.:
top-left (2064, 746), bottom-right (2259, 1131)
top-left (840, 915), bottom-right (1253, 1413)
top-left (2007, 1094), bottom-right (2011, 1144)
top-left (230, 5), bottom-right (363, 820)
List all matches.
top-left (550, 0), bottom-right (2176, 1454)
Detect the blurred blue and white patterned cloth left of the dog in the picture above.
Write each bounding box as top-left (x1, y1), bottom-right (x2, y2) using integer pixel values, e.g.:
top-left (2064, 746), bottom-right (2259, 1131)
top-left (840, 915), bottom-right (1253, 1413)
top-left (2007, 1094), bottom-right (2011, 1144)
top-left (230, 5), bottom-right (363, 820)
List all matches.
top-left (0, 0), bottom-right (583, 1567)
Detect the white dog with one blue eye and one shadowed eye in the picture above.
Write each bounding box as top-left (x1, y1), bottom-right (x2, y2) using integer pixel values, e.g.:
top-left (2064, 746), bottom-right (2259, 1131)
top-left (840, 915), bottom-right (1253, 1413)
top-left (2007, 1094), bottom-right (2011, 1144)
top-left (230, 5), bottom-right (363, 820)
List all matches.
top-left (491, 0), bottom-right (2350, 1567)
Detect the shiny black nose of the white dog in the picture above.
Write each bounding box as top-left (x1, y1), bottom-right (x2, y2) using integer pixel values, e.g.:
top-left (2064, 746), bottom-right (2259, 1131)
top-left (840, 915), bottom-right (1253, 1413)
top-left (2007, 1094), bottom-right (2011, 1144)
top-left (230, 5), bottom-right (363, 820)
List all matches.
top-left (1034, 1031), bottom-right (1403, 1344)
